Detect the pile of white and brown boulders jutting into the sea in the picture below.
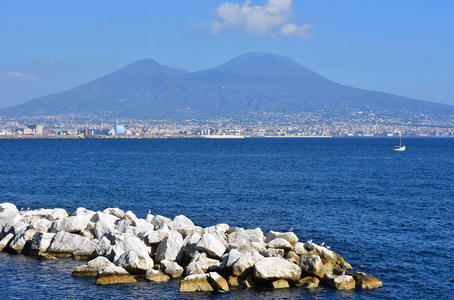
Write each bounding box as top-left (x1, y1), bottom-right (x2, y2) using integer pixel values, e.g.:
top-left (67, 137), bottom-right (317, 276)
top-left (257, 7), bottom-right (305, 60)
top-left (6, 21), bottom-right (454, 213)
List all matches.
top-left (0, 203), bottom-right (382, 292)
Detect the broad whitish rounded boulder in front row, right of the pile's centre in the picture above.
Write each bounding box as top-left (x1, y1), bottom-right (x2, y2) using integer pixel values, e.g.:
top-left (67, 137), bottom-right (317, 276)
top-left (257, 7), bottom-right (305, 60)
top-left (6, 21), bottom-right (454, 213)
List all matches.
top-left (254, 257), bottom-right (301, 281)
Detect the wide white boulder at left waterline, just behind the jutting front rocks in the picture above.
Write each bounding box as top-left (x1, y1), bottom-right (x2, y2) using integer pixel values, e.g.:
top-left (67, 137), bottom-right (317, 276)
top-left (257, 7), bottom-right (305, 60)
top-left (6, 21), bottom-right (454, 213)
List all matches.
top-left (47, 231), bottom-right (89, 257)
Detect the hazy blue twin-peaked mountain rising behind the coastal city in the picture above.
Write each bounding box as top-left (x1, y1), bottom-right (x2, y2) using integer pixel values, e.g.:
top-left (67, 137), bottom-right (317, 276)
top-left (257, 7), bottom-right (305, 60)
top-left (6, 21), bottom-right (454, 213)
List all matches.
top-left (0, 52), bottom-right (454, 118)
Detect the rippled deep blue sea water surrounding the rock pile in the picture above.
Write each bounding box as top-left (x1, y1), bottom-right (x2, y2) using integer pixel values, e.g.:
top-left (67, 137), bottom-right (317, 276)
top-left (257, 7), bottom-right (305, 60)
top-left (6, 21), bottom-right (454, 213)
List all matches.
top-left (0, 138), bottom-right (454, 299)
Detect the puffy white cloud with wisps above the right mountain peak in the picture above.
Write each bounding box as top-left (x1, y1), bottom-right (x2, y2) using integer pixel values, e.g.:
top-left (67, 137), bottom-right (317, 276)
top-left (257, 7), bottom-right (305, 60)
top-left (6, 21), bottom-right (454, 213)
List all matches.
top-left (207, 0), bottom-right (314, 38)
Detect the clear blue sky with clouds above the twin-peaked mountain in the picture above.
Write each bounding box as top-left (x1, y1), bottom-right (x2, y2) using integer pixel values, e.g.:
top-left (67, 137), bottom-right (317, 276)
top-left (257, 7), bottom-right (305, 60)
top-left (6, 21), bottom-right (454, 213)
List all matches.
top-left (0, 0), bottom-right (454, 108)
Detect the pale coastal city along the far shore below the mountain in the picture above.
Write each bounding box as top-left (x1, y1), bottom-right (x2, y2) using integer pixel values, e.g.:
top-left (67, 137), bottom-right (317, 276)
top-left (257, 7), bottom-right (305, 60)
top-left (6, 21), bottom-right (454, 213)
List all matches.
top-left (0, 107), bottom-right (454, 138)
